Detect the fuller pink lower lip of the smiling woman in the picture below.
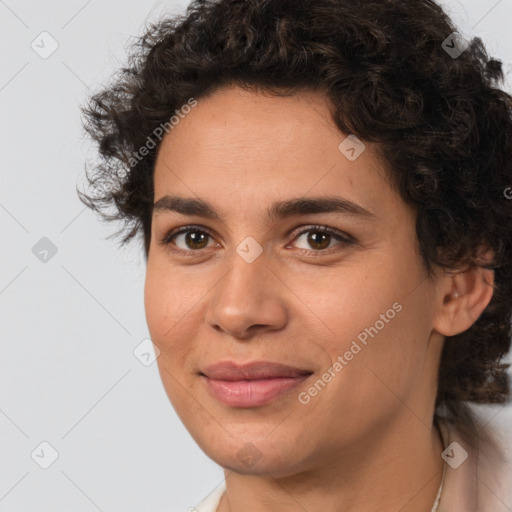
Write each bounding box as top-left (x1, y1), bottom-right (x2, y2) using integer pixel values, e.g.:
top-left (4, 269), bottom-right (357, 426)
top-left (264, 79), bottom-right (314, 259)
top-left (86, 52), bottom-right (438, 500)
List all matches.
top-left (204, 375), bottom-right (309, 407)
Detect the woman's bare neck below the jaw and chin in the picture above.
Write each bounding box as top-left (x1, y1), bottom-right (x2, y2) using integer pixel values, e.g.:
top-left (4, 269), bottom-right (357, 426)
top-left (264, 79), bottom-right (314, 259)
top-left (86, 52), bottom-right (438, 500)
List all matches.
top-left (217, 412), bottom-right (444, 512)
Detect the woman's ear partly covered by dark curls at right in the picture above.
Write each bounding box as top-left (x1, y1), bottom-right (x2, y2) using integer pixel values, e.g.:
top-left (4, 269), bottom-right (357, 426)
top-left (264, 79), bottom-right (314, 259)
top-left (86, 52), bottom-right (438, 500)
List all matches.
top-left (433, 249), bottom-right (494, 336)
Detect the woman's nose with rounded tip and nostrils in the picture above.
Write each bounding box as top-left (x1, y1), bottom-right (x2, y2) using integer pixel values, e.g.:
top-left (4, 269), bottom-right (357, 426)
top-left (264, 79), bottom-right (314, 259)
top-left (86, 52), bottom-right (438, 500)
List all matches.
top-left (206, 248), bottom-right (288, 339)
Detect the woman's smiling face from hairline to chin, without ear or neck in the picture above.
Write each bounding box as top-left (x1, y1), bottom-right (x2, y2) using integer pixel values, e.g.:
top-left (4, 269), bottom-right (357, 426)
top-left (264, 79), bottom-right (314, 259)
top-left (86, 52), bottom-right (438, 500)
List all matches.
top-left (145, 87), bottom-right (440, 475)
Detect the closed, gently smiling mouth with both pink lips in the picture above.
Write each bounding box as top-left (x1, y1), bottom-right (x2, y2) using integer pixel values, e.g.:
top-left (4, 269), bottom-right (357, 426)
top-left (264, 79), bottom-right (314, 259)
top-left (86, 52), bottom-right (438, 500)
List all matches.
top-left (199, 361), bottom-right (313, 408)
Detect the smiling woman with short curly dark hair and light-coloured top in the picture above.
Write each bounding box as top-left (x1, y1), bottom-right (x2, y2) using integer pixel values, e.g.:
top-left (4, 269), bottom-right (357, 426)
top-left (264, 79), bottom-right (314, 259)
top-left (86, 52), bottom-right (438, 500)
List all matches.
top-left (80, 0), bottom-right (512, 512)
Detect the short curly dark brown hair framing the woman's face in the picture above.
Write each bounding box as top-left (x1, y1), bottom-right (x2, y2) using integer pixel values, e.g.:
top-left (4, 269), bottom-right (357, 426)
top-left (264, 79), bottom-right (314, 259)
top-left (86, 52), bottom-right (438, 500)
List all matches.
top-left (78, 0), bottom-right (512, 424)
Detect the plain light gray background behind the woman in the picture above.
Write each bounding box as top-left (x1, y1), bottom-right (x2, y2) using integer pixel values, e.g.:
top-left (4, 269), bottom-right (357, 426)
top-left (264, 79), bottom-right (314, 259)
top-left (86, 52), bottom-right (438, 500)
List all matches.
top-left (0, 0), bottom-right (512, 512)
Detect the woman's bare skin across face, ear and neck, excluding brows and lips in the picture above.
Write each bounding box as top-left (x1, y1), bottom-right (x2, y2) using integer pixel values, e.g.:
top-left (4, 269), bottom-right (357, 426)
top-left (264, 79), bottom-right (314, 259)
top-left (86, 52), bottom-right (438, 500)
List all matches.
top-left (145, 87), bottom-right (493, 512)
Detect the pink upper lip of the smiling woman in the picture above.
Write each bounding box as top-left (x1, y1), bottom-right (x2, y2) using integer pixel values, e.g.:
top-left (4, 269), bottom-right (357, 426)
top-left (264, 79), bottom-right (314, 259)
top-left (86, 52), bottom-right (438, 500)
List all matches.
top-left (201, 361), bottom-right (313, 381)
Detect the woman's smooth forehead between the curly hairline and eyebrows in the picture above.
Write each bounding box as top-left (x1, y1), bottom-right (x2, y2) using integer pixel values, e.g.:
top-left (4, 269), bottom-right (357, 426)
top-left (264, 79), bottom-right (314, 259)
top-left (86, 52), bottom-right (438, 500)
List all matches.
top-left (154, 87), bottom-right (397, 220)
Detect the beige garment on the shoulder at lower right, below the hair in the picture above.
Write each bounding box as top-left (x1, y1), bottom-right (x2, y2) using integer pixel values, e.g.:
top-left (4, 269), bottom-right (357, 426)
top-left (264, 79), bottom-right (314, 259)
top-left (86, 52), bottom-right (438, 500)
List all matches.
top-left (439, 407), bottom-right (512, 512)
